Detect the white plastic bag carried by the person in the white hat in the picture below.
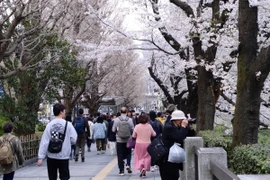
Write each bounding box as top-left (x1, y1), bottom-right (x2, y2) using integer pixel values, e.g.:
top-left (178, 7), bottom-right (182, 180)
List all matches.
top-left (168, 143), bottom-right (186, 163)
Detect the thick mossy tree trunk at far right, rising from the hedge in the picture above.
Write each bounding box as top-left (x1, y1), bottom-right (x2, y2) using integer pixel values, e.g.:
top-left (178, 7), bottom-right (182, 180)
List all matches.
top-left (233, 0), bottom-right (269, 147)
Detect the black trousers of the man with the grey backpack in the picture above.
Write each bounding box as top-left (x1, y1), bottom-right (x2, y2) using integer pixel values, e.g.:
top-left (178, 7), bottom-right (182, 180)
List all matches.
top-left (116, 142), bottom-right (131, 172)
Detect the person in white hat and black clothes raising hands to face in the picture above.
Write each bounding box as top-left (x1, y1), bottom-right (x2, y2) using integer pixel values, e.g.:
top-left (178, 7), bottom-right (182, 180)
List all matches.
top-left (159, 110), bottom-right (192, 180)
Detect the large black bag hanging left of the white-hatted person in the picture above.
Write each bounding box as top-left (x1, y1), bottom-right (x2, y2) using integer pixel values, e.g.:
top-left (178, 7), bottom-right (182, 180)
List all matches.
top-left (147, 135), bottom-right (169, 165)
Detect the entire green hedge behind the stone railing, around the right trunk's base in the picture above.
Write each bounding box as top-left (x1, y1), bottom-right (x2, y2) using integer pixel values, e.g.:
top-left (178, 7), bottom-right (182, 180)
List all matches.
top-left (198, 127), bottom-right (270, 174)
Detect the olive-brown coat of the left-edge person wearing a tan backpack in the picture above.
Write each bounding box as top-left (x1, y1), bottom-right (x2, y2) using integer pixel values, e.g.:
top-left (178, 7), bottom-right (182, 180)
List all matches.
top-left (0, 133), bottom-right (24, 174)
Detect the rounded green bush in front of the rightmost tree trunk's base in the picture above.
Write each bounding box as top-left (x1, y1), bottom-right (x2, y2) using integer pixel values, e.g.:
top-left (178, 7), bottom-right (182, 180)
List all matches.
top-left (229, 144), bottom-right (270, 174)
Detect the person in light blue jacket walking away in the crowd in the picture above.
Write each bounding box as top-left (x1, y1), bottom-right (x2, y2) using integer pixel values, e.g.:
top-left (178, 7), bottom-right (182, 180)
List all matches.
top-left (93, 116), bottom-right (106, 155)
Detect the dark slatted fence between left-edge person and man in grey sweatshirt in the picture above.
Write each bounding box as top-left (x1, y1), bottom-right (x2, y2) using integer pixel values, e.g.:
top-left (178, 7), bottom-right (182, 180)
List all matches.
top-left (19, 134), bottom-right (40, 160)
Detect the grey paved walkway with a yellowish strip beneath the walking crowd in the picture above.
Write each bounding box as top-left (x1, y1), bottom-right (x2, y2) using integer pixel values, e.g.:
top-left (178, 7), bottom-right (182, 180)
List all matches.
top-left (14, 144), bottom-right (161, 180)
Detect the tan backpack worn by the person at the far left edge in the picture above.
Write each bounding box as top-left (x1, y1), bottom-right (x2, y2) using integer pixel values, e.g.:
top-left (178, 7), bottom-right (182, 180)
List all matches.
top-left (0, 135), bottom-right (15, 164)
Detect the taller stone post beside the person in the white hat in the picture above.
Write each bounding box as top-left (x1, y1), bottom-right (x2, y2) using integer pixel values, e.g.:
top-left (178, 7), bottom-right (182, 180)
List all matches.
top-left (180, 137), bottom-right (203, 180)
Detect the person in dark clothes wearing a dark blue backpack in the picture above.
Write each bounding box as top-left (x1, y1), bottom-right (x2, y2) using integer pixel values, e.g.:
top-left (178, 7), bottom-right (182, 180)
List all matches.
top-left (73, 109), bottom-right (90, 162)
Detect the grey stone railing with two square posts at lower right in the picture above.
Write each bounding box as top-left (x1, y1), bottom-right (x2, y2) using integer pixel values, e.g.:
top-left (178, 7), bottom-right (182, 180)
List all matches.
top-left (180, 137), bottom-right (239, 180)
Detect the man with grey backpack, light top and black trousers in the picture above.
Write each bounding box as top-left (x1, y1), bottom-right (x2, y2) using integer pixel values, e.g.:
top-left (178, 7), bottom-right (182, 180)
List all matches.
top-left (112, 107), bottom-right (134, 176)
